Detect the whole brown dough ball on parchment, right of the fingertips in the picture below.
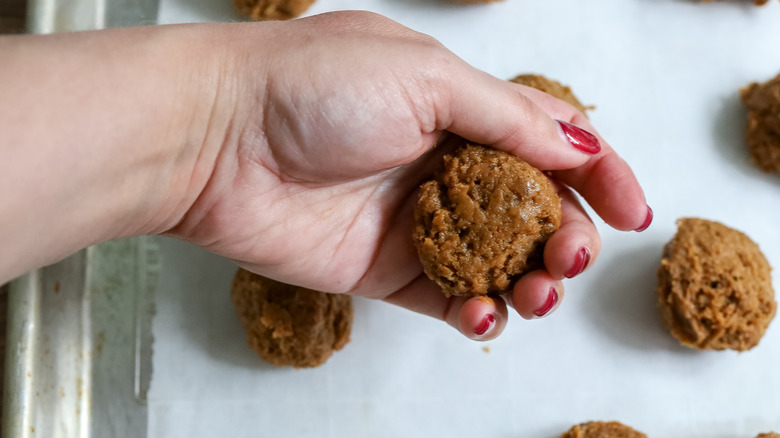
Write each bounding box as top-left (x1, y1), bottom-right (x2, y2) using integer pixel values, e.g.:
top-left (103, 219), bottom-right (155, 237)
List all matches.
top-left (656, 218), bottom-right (777, 351)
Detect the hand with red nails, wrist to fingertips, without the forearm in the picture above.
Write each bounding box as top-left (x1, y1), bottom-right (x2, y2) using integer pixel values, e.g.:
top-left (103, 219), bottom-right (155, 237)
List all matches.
top-left (169, 12), bottom-right (650, 340)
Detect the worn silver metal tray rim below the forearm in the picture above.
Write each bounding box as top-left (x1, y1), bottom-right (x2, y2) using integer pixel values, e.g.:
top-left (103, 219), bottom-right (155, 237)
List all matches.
top-left (3, 237), bottom-right (160, 438)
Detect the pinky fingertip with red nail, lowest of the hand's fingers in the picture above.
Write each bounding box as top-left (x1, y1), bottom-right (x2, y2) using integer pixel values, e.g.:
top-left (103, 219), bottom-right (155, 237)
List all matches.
top-left (455, 296), bottom-right (507, 341)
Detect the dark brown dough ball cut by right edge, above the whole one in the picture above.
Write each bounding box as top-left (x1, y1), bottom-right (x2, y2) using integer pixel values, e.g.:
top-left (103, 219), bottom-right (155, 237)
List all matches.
top-left (740, 75), bottom-right (780, 173)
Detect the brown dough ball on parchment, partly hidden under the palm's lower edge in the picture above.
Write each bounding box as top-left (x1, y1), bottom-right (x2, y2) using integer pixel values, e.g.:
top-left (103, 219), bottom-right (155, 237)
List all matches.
top-left (231, 269), bottom-right (353, 368)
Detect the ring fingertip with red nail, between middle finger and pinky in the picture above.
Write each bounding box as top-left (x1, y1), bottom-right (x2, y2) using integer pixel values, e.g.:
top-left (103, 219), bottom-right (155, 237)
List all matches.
top-left (512, 270), bottom-right (563, 319)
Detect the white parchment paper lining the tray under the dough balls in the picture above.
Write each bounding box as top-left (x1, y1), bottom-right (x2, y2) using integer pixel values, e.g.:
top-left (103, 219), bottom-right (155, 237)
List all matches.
top-left (149, 0), bottom-right (780, 438)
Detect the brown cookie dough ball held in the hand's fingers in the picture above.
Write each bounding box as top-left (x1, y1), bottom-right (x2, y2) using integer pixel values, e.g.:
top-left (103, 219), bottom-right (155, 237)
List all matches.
top-left (413, 144), bottom-right (561, 296)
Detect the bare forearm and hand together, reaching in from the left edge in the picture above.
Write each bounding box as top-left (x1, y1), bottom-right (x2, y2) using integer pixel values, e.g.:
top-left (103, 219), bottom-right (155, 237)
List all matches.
top-left (0, 12), bottom-right (648, 340)
